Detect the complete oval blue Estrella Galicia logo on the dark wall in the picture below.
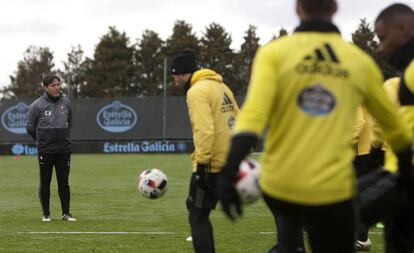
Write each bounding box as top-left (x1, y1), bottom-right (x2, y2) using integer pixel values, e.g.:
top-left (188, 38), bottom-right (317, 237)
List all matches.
top-left (96, 101), bottom-right (137, 133)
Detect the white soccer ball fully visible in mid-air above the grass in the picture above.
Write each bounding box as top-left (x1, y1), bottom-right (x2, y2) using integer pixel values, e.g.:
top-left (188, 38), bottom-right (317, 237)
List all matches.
top-left (138, 168), bottom-right (168, 199)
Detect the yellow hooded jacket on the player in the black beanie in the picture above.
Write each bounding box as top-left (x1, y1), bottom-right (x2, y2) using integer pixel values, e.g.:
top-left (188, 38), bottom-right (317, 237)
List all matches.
top-left (187, 69), bottom-right (239, 173)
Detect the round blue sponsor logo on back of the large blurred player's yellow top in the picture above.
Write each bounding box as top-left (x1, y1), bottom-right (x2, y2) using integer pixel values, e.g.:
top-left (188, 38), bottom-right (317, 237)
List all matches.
top-left (297, 84), bottom-right (336, 116)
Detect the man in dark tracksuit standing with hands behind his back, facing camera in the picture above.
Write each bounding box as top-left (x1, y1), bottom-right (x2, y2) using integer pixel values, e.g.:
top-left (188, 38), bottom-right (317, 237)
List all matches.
top-left (26, 75), bottom-right (76, 221)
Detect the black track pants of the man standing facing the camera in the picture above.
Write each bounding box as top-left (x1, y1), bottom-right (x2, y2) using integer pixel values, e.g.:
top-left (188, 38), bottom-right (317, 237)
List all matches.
top-left (38, 153), bottom-right (70, 216)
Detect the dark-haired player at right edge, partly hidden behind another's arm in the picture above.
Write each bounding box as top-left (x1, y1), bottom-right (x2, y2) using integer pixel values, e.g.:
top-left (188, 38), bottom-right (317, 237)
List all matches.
top-left (375, 4), bottom-right (414, 253)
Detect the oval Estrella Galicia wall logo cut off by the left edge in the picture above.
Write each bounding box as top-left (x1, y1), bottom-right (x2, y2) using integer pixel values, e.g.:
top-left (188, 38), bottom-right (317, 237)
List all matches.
top-left (1, 102), bottom-right (29, 134)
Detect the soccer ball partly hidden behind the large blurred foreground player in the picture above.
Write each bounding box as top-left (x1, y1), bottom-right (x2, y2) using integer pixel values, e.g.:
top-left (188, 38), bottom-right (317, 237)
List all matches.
top-left (236, 159), bottom-right (261, 204)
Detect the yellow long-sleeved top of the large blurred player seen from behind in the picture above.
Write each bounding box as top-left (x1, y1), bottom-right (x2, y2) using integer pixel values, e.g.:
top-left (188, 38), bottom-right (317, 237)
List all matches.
top-left (235, 24), bottom-right (411, 205)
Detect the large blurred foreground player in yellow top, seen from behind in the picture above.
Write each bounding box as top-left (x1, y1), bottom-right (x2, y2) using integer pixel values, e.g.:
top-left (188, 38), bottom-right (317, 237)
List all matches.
top-left (218, 0), bottom-right (411, 253)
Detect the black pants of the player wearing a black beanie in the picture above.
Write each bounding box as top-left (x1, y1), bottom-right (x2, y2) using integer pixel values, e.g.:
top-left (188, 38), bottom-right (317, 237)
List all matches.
top-left (186, 173), bottom-right (218, 253)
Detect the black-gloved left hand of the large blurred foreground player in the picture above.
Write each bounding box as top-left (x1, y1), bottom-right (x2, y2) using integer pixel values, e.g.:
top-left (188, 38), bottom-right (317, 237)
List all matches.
top-left (217, 167), bottom-right (243, 220)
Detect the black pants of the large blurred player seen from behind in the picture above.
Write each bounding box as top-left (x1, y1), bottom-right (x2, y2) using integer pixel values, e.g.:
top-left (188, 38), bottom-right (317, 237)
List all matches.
top-left (263, 194), bottom-right (355, 253)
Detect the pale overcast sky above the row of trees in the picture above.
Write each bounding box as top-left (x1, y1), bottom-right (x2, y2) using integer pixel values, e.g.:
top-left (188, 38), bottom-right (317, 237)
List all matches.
top-left (0, 0), bottom-right (414, 90)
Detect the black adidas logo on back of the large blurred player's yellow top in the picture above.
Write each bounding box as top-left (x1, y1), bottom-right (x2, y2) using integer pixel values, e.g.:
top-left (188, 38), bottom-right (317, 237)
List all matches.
top-left (295, 43), bottom-right (349, 78)
